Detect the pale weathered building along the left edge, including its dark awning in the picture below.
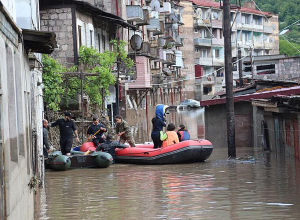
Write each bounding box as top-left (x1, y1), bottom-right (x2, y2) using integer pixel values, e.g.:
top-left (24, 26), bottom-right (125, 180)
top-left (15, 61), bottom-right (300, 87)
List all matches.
top-left (0, 0), bottom-right (56, 220)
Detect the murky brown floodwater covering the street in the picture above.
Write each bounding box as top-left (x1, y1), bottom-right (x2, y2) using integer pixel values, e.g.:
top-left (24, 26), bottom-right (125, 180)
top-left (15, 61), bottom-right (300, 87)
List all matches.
top-left (37, 111), bottom-right (300, 220)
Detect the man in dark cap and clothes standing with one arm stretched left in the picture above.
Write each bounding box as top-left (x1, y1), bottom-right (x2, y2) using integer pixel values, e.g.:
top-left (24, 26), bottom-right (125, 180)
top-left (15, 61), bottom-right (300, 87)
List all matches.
top-left (51, 112), bottom-right (79, 156)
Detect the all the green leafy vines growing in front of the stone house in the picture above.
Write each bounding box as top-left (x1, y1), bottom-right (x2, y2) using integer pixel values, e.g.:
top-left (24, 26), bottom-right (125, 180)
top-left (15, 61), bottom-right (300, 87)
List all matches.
top-left (43, 40), bottom-right (134, 110)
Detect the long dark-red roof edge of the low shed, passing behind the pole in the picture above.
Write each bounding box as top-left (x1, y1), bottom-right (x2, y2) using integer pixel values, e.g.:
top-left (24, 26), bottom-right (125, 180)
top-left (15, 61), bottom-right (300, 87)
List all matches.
top-left (200, 86), bottom-right (300, 107)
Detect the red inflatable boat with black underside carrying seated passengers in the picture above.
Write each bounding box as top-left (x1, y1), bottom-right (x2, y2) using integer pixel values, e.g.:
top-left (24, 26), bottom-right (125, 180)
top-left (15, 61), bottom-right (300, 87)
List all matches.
top-left (80, 139), bottom-right (213, 164)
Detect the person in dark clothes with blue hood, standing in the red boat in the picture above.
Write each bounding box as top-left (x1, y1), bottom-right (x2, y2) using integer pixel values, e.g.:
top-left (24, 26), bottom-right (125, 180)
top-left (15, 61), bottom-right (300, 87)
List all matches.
top-left (151, 104), bottom-right (168, 148)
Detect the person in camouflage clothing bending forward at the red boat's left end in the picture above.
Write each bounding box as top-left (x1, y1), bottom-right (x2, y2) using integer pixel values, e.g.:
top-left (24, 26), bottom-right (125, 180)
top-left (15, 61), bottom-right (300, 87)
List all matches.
top-left (116, 115), bottom-right (135, 147)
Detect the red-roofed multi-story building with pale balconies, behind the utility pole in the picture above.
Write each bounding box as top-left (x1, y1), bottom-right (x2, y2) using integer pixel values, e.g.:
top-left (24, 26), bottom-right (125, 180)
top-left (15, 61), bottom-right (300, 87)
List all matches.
top-left (181, 0), bottom-right (279, 100)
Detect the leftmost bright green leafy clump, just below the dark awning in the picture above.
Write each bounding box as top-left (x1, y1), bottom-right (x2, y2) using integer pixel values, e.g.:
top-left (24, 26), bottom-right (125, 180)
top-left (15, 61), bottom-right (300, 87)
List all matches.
top-left (42, 55), bottom-right (64, 111)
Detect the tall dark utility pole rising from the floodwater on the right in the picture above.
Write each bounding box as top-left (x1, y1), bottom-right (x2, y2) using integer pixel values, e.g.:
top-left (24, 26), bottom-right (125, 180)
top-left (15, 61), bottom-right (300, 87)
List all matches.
top-left (223, 0), bottom-right (236, 158)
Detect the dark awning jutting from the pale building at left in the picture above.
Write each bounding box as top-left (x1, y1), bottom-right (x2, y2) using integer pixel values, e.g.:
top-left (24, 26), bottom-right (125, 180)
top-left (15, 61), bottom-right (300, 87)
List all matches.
top-left (22, 29), bottom-right (57, 54)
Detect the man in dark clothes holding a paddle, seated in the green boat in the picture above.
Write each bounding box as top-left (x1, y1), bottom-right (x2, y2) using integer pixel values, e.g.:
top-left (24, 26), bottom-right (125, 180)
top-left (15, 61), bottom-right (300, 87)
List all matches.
top-left (87, 117), bottom-right (107, 147)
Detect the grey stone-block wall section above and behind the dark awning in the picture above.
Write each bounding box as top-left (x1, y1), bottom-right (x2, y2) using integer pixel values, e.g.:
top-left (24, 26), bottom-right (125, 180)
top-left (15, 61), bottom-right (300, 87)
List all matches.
top-left (40, 8), bottom-right (74, 66)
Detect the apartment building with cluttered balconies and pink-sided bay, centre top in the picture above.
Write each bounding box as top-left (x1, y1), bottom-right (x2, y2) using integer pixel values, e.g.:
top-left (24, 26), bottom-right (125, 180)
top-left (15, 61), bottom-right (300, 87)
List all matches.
top-left (124, 0), bottom-right (184, 109)
